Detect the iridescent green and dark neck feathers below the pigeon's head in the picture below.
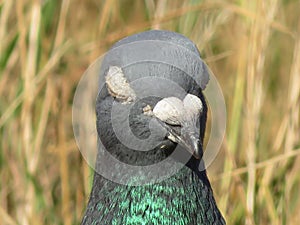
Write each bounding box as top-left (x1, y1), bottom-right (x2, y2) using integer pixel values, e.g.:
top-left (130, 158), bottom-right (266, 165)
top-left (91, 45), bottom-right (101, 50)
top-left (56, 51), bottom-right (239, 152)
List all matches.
top-left (83, 167), bottom-right (225, 225)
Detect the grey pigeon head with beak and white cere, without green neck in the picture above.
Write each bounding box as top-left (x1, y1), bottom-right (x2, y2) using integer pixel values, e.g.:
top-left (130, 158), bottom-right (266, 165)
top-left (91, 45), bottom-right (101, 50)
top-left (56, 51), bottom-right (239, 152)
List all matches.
top-left (96, 31), bottom-right (209, 165)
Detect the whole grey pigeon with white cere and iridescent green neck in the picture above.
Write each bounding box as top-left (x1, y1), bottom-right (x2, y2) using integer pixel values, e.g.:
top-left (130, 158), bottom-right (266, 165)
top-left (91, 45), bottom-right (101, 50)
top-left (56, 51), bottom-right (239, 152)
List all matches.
top-left (81, 30), bottom-right (226, 225)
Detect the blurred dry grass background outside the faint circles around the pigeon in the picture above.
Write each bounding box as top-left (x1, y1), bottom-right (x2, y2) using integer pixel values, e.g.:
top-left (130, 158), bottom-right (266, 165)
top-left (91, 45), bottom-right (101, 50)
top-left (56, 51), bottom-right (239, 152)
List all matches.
top-left (0, 0), bottom-right (300, 225)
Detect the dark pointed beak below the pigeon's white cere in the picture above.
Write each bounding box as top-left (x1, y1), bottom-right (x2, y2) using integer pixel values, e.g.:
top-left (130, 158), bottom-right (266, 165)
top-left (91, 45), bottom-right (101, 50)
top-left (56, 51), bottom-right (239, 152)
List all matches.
top-left (160, 121), bottom-right (202, 159)
